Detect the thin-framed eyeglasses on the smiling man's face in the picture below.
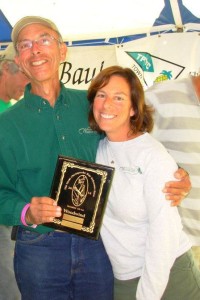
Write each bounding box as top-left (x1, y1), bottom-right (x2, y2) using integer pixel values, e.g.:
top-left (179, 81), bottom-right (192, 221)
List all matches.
top-left (16, 34), bottom-right (62, 52)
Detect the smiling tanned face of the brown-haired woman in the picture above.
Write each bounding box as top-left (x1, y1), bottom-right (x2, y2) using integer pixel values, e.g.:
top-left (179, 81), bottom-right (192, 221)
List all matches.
top-left (93, 75), bottom-right (134, 141)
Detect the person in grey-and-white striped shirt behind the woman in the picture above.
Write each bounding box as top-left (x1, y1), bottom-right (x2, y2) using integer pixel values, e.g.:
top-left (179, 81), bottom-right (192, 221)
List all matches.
top-left (146, 75), bottom-right (200, 267)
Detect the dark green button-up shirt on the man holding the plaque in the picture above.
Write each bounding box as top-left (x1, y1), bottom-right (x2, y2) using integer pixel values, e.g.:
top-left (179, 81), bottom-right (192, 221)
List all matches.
top-left (0, 84), bottom-right (100, 233)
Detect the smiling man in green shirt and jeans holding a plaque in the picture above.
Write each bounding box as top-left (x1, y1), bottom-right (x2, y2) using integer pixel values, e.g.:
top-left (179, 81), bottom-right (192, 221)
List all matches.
top-left (0, 16), bottom-right (190, 300)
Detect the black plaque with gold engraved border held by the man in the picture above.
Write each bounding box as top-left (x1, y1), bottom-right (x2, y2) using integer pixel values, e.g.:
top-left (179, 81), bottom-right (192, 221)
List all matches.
top-left (45, 156), bottom-right (114, 240)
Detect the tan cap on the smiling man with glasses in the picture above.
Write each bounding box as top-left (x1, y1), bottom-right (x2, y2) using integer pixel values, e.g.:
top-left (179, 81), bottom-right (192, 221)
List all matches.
top-left (11, 16), bottom-right (61, 45)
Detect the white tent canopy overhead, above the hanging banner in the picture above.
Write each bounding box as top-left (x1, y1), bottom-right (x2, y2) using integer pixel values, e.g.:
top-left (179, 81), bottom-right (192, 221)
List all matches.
top-left (1, 0), bottom-right (200, 41)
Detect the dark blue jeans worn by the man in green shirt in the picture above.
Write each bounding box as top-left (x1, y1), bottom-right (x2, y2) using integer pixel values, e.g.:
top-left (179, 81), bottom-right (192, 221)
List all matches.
top-left (14, 228), bottom-right (113, 300)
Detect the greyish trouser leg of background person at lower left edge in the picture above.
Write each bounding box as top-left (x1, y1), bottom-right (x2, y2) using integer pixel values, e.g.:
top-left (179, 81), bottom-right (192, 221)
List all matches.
top-left (0, 225), bottom-right (21, 300)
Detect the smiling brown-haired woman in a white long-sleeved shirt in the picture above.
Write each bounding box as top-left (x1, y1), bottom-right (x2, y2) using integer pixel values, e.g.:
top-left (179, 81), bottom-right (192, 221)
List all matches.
top-left (88, 66), bottom-right (200, 300)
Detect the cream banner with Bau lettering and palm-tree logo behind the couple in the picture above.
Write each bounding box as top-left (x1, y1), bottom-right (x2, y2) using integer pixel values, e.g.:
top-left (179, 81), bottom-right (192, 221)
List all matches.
top-left (60, 32), bottom-right (200, 89)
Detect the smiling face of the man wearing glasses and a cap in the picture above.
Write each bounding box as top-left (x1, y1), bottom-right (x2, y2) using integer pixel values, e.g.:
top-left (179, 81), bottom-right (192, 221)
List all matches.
top-left (15, 24), bottom-right (67, 82)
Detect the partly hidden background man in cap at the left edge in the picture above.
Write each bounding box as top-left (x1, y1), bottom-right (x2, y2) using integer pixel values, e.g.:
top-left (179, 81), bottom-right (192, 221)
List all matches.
top-left (0, 44), bottom-right (28, 300)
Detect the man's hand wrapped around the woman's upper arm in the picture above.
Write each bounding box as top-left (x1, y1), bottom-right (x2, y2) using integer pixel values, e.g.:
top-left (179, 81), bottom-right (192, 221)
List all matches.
top-left (163, 168), bottom-right (191, 206)
